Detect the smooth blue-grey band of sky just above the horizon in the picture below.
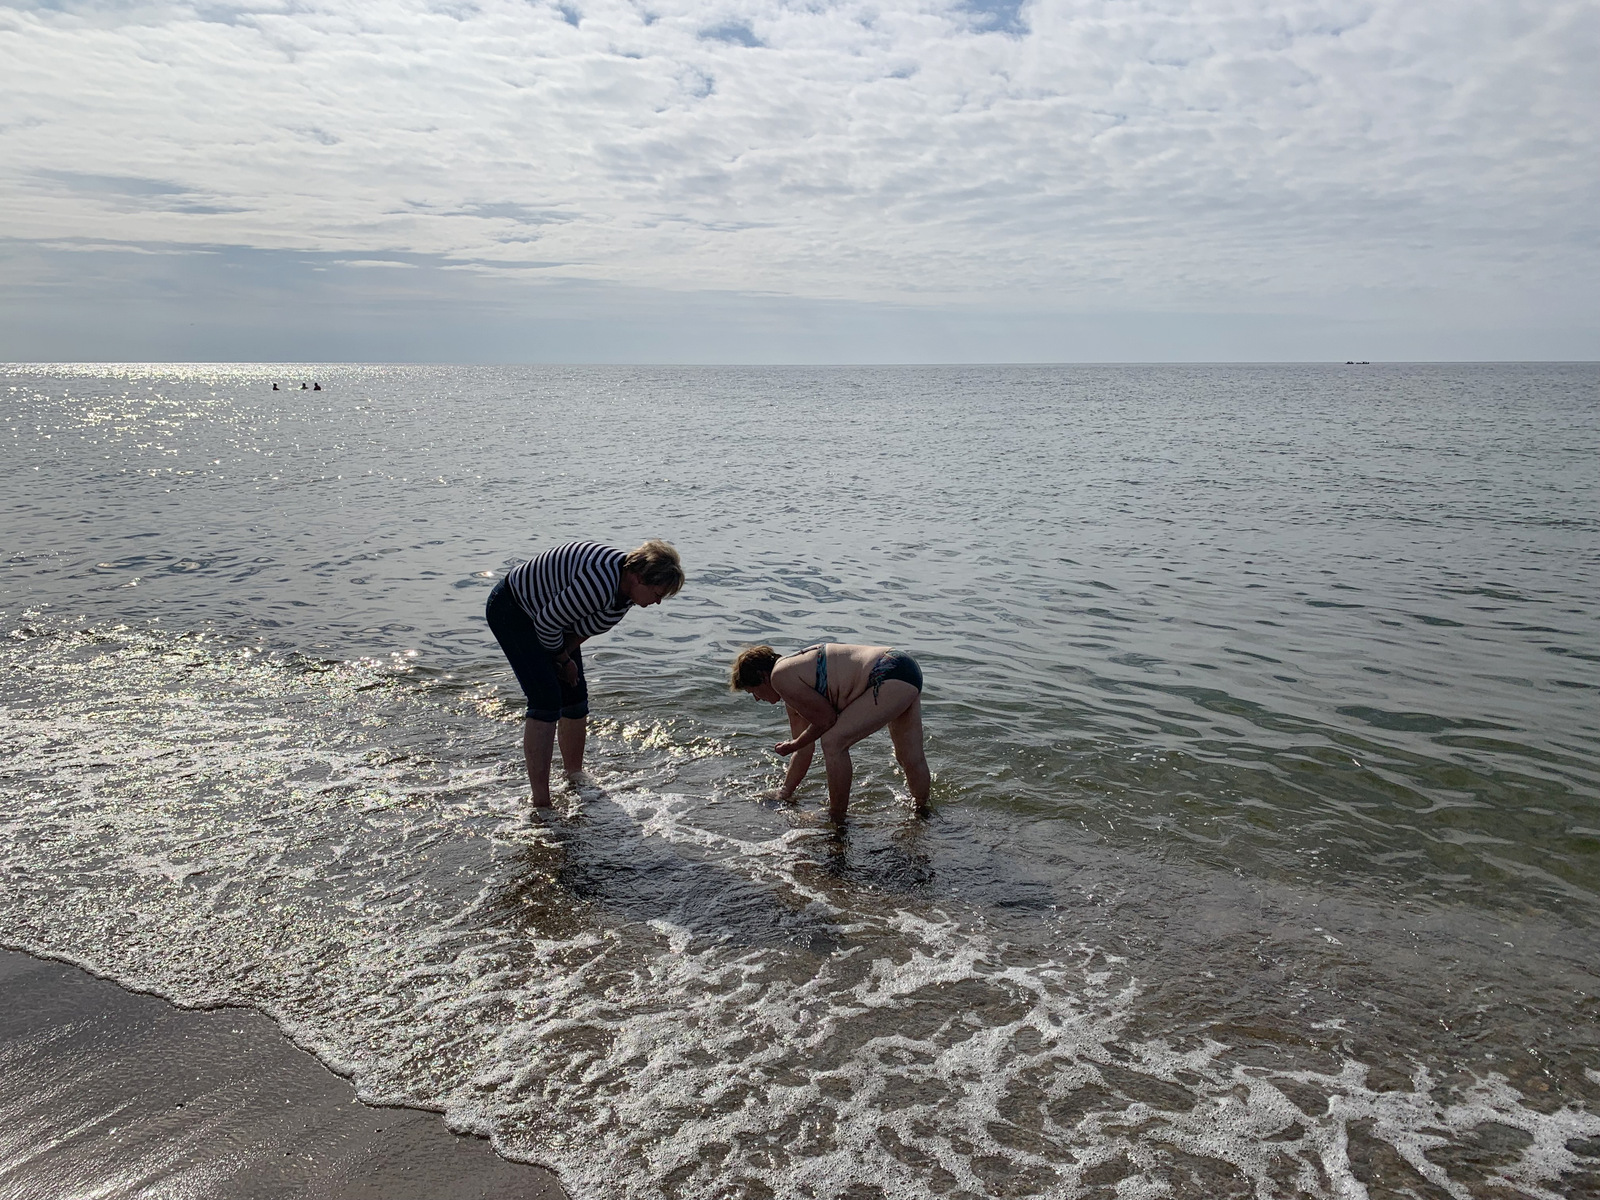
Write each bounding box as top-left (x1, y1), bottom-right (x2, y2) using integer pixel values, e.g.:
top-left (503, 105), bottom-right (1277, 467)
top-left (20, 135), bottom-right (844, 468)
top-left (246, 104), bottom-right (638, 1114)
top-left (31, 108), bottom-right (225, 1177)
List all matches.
top-left (12, 238), bottom-right (1600, 363)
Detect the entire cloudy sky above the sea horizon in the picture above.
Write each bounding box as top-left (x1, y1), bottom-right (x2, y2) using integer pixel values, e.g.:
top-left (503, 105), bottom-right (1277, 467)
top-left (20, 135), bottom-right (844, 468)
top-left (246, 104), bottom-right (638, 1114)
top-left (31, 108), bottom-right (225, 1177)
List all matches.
top-left (0, 0), bottom-right (1600, 363)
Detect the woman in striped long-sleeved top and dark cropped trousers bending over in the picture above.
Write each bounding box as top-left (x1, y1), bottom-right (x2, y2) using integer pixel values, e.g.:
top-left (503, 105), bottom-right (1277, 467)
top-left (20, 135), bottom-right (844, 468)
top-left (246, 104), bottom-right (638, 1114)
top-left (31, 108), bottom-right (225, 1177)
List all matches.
top-left (485, 541), bottom-right (683, 808)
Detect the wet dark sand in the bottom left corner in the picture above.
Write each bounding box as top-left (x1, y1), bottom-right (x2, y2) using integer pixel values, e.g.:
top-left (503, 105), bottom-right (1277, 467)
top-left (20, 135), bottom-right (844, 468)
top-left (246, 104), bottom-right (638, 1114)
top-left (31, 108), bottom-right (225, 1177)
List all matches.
top-left (0, 950), bottom-right (565, 1200)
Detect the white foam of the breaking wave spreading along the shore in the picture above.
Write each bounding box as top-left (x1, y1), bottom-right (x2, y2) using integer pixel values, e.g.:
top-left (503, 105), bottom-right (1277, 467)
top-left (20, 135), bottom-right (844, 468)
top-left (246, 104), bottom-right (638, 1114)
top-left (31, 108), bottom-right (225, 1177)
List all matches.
top-left (0, 632), bottom-right (1600, 1200)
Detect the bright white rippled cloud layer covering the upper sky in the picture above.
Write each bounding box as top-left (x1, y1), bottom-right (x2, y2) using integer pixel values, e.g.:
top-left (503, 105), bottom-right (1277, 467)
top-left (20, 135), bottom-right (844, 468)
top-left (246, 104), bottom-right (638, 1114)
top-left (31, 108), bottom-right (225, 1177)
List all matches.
top-left (0, 0), bottom-right (1600, 360)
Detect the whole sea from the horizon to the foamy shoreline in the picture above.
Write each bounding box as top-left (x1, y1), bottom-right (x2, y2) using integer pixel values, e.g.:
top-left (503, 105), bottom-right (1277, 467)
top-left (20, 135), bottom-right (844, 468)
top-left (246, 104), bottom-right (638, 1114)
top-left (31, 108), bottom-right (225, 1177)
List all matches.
top-left (0, 363), bottom-right (1600, 1200)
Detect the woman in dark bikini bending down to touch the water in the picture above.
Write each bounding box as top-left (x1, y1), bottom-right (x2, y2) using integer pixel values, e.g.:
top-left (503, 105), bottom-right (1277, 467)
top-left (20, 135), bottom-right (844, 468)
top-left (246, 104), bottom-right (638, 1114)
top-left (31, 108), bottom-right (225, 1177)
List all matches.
top-left (728, 642), bottom-right (931, 821)
